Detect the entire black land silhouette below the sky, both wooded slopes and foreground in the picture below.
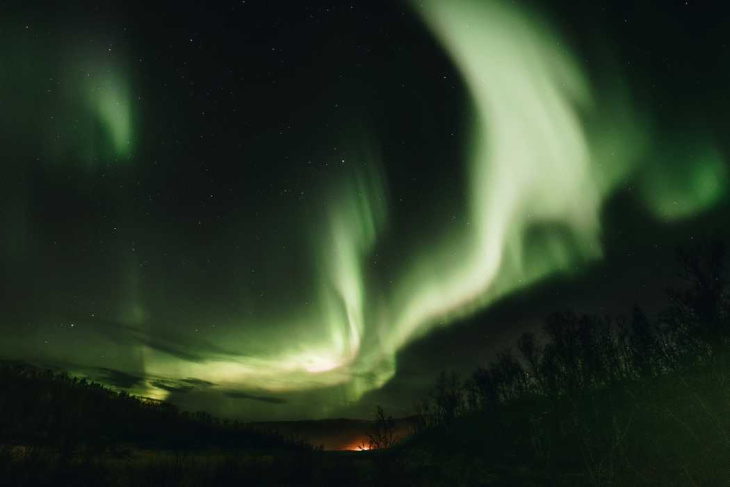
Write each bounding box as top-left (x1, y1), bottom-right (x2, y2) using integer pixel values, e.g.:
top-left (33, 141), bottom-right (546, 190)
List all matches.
top-left (0, 241), bottom-right (730, 486)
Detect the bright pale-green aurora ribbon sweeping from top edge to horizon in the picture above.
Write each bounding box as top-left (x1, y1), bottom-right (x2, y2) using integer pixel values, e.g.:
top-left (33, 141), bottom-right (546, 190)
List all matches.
top-left (126, 0), bottom-right (725, 400)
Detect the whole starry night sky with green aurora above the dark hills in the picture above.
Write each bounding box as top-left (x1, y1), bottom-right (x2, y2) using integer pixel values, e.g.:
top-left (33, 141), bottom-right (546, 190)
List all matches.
top-left (0, 0), bottom-right (730, 420)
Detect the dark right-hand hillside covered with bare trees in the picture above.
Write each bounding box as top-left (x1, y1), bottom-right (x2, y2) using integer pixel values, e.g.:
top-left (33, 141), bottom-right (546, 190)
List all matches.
top-left (373, 241), bottom-right (730, 485)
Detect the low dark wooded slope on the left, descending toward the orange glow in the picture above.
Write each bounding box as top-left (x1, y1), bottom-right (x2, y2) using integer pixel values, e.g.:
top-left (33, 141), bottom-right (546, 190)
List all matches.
top-left (0, 363), bottom-right (309, 456)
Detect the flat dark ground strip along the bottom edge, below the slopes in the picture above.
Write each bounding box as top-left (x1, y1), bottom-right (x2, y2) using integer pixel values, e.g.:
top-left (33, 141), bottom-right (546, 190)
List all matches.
top-left (0, 447), bottom-right (580, 487)
